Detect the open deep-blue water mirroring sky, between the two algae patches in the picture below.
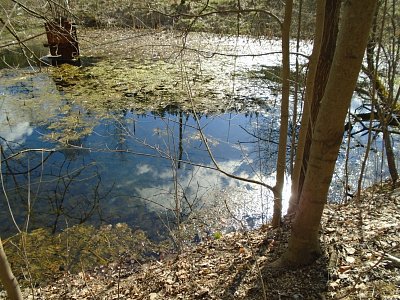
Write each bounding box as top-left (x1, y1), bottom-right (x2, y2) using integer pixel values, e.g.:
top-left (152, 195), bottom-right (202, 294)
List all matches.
top-left (0, 89), bottom-right (272, 238)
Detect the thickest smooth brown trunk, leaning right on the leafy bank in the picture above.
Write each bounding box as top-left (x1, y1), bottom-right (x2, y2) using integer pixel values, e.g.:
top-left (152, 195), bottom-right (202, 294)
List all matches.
top-left (274, 0), bottom-right (377, 267)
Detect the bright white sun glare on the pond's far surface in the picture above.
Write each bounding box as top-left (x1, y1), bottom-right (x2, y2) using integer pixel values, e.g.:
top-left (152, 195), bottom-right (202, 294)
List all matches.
top-left (180, 33), bottom-right (312, 113)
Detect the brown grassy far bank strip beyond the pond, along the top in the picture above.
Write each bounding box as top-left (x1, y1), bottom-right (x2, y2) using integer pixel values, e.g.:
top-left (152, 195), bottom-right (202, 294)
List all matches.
top-left (0, 0), bottom-right (315, 38)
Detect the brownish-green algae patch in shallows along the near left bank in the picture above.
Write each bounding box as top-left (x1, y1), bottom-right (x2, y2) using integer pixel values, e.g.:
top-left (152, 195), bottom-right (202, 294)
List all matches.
top-left (4, 224), bottom-right (164, 284)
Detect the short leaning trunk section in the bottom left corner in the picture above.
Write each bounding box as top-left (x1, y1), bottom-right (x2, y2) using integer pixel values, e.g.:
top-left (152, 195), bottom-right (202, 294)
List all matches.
top-left (0, 238), bottom-right (22, 300)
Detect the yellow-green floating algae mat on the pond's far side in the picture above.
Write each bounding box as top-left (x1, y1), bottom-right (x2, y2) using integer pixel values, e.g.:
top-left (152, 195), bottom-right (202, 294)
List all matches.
top-left (46, 58), bottom-right (234, 118)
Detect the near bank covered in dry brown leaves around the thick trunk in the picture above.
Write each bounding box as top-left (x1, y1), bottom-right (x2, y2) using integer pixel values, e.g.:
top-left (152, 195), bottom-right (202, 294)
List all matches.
top-left (12, 180), bottom-right (400, 300)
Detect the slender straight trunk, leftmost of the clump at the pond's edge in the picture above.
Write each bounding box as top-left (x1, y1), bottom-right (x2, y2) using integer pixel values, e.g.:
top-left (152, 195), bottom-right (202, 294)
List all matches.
top-left (271, 0), bottom-right (293, 227)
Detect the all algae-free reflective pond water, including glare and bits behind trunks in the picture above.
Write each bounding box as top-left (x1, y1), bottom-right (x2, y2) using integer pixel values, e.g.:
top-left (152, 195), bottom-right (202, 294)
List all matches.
top-left (0, 32), bottom-right (397, 238)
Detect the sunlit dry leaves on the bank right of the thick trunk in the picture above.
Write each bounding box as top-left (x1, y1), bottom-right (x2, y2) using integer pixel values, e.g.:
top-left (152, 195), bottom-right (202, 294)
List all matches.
top-left (322, 185), bottom-right (400, 299)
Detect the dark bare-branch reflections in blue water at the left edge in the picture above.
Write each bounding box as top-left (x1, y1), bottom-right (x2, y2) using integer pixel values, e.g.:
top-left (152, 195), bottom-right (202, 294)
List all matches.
top-left (0, 143), bottom-right (105, 234)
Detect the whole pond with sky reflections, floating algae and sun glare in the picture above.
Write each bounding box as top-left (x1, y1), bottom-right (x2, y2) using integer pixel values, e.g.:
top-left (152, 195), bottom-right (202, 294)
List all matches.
top-left (0, 30), bottom-right (394, 239)
